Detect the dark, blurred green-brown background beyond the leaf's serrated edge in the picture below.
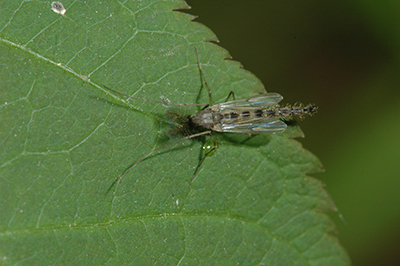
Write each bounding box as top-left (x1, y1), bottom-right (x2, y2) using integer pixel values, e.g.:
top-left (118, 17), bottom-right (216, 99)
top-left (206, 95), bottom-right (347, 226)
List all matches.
top-left (185, 0), bottom-right (400, 266)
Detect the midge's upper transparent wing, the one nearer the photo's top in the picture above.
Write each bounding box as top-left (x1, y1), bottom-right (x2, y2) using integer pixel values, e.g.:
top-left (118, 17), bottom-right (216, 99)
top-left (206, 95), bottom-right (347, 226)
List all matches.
top-left (216, 92), bottom-right (283, 112)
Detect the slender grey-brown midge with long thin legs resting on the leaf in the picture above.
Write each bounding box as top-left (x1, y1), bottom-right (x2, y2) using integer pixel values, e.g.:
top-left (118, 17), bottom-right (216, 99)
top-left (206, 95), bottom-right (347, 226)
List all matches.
top-left (107, 48), bottom-right (318, 190)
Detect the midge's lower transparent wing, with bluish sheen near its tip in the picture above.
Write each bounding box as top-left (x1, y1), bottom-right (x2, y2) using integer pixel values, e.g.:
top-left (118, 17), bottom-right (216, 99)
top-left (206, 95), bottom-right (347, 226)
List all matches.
top-left (214, 117), bottom-right (287, 134)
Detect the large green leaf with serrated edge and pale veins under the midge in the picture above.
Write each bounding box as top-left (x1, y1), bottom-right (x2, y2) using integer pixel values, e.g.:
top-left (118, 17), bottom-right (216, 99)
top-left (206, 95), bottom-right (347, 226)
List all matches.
top-left (0, 0), bottom-right (349, 265)
